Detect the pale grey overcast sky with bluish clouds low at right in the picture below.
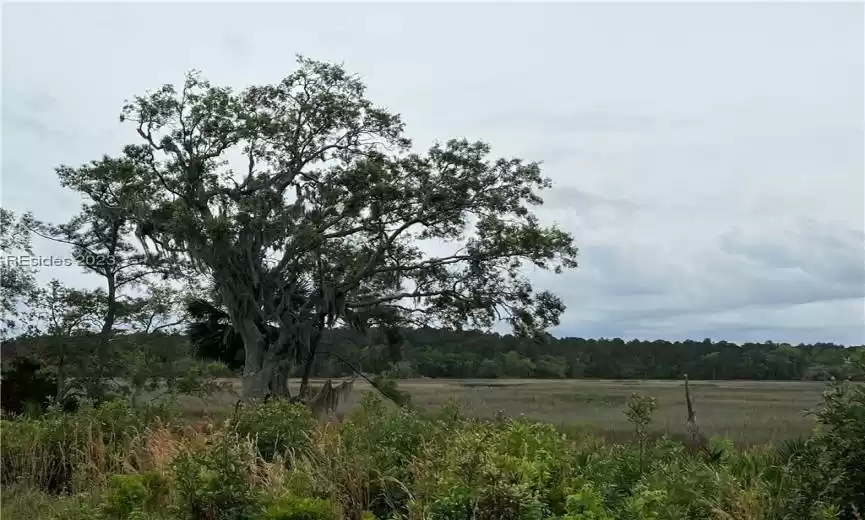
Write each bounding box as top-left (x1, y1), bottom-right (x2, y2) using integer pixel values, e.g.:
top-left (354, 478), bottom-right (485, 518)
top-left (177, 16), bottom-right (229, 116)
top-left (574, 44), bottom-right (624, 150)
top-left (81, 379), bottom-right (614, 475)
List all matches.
top-left (2, 3), bottom-right (865, 344)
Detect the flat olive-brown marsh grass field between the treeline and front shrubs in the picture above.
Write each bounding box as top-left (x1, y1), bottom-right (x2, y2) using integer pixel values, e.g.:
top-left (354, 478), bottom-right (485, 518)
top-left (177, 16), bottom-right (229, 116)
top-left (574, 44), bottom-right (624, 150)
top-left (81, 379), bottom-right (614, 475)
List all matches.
top-left (172, 379), bottom-right (825, 444)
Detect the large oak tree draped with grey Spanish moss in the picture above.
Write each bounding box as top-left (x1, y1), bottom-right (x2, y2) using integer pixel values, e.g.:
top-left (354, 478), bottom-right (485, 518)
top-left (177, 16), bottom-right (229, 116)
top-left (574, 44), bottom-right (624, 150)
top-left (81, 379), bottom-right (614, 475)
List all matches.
top-left (77, 58), bottom-right (577, 396)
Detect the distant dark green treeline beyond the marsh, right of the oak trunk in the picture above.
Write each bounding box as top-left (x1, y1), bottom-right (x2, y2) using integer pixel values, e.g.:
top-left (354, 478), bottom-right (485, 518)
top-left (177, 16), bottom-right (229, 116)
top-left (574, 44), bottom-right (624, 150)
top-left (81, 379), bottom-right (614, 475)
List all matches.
top-left (388, 330), bottom-right (852, 380)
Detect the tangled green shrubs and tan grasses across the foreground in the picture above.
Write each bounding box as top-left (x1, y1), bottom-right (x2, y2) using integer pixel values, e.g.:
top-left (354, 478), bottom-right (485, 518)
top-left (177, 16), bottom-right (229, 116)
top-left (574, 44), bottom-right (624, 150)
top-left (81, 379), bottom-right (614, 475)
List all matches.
top-left (2, 370), bottom-right (865, 520)
